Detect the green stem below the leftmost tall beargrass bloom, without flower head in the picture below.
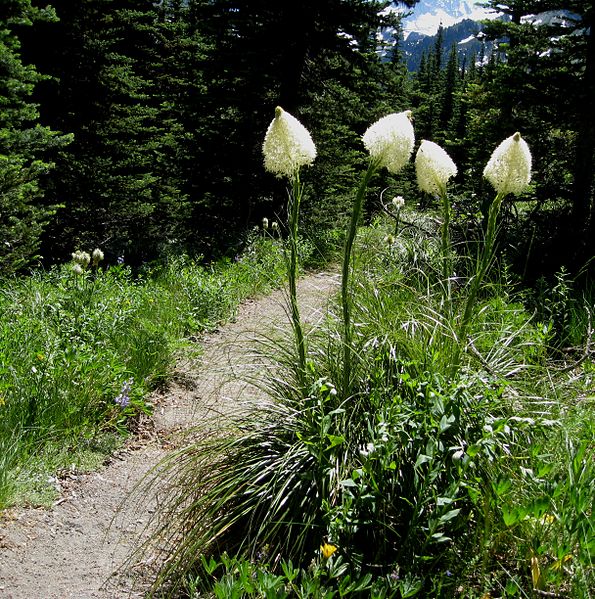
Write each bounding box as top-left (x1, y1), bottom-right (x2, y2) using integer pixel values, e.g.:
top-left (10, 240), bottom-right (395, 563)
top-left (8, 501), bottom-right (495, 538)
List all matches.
top-left (288, 172), bottom-right (306, 380)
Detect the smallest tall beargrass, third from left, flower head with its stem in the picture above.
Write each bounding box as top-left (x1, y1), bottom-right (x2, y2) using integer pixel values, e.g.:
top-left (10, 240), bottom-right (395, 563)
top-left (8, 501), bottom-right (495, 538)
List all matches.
top-left (415, 139), bottom-right (457, 284)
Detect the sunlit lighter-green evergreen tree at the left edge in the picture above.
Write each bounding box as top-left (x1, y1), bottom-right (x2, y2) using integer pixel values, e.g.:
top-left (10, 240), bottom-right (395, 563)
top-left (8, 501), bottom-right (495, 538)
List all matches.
top-left (0, 0), bottom-right (68, 273)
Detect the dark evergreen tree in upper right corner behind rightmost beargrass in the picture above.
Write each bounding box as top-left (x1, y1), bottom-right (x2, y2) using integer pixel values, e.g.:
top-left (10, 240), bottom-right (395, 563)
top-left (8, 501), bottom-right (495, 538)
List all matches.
top-left (486, 0), bottom-right (595, 262)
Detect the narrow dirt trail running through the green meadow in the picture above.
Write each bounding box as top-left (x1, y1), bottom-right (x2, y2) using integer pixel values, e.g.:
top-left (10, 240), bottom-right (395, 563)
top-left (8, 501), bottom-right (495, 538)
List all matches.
top-left (0, 273), bottom-right (338, 599)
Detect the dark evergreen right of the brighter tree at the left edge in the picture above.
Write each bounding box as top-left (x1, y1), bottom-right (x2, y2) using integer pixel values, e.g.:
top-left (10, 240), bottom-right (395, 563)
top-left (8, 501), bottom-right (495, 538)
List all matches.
top-left (24, 0), bottom-right (192, 262)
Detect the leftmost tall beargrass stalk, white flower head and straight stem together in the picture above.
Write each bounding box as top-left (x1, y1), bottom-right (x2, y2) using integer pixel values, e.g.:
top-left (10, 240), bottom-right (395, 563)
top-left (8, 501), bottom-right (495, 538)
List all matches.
top-left (262, 106), bottom-right (316, 375)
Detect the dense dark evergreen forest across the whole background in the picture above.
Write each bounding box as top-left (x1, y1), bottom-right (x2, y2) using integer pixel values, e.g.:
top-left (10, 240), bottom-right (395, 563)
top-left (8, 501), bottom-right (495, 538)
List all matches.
top-left (0, 0), bottom-right (595, 274)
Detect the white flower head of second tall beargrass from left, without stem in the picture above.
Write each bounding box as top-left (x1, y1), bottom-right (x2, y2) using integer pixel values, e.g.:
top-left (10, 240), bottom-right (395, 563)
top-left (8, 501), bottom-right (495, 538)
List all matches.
top-left (363, 110), bottom-right (415, 173)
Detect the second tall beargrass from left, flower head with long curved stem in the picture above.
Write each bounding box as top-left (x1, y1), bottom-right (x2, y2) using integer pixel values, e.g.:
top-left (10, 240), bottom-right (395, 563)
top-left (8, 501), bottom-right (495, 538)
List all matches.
top-left (341, 110), bottom-right (415, 396)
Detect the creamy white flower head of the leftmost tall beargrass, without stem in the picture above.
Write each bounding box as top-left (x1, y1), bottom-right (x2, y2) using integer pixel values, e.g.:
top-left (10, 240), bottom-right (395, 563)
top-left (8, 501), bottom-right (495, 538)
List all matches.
top-left (262, 106), bottom-right (316, 178)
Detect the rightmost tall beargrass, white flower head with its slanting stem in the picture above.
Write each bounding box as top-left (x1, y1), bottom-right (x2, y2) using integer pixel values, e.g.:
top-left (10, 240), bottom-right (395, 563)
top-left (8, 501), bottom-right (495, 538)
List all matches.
top-left (457, 132), bottom-right (532, 372)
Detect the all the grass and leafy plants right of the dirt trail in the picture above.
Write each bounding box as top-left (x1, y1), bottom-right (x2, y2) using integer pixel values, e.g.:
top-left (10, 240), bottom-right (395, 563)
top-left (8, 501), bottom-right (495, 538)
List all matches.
top-left (137, 213), bottom-right (595, 599)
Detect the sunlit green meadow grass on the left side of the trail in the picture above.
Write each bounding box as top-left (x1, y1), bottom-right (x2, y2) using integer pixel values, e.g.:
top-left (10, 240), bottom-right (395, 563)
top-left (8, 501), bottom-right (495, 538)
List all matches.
top-left (0, 234), bottom-right (292, 509)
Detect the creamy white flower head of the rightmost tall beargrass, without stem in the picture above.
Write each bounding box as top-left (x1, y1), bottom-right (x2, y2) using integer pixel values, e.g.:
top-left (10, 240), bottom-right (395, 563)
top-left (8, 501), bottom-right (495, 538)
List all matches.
top-left (483, 132), bottom-right (531, 196)
